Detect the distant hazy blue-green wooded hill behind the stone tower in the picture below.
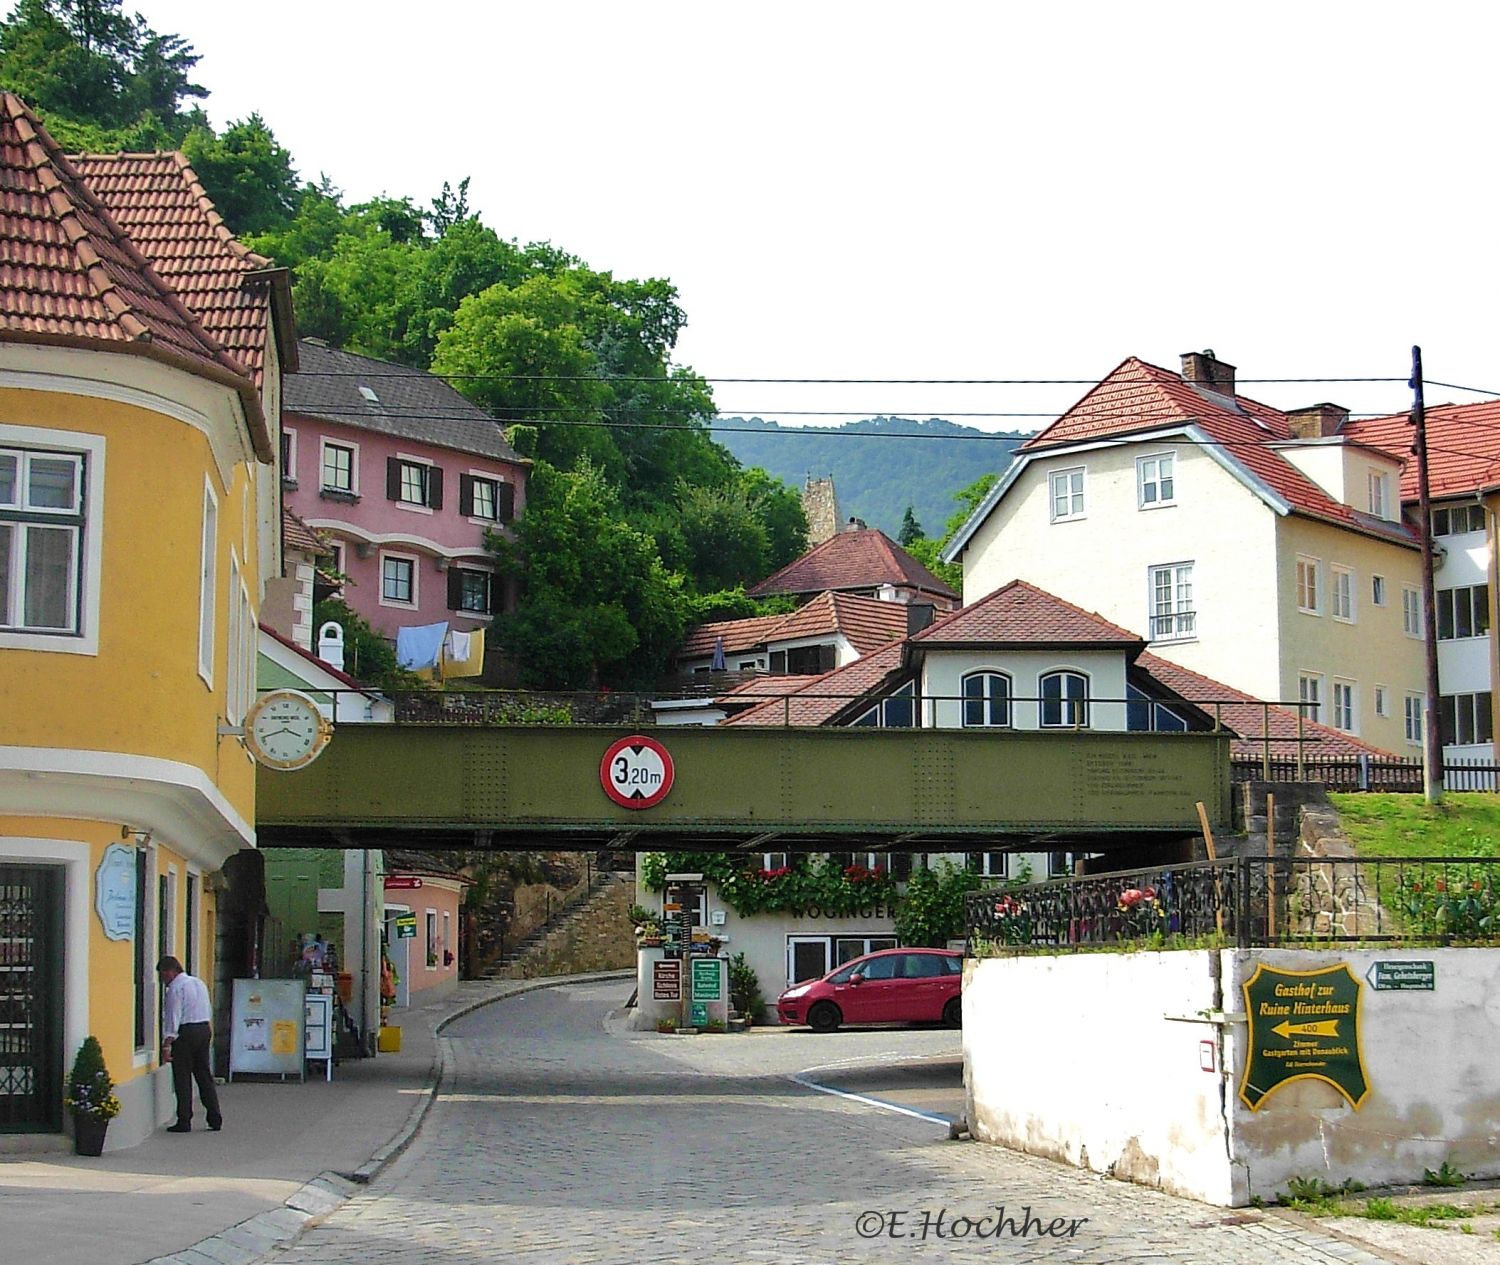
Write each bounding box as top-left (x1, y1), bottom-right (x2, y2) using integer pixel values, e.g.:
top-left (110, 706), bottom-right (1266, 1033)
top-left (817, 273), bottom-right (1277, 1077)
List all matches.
top-left (714, 417), bottom-right (1026, 537)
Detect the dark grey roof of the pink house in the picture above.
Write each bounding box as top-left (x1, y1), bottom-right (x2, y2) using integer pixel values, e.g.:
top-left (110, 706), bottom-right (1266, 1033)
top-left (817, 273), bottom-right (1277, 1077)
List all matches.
top-left (282, 339), bottom-right (531, 465)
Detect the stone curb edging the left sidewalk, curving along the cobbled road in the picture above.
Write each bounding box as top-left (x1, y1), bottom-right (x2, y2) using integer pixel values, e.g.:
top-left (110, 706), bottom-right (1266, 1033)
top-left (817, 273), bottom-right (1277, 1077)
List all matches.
top-left (141, 969), bottom-right (636, 1265)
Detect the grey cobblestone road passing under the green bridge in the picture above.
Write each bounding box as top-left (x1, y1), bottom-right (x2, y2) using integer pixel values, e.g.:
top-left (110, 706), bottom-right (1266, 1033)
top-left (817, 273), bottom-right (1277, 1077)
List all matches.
top-left (278, 984), bottom-right (1383, 1265)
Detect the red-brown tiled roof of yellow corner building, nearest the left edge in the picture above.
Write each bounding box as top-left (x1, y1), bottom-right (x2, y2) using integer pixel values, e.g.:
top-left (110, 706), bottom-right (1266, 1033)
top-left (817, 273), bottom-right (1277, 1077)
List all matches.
top-left (0, 93), bottom-right (272, 461)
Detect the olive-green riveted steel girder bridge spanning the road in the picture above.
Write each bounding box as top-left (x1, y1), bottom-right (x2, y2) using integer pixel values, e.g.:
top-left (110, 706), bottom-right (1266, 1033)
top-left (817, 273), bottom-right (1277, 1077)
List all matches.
top-left (257, 723), bottom-right (1230, 852)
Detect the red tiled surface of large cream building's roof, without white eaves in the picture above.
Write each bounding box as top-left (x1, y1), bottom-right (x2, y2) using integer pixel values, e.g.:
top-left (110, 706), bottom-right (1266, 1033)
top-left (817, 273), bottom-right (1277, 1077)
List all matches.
top-left (1020, 356), bottom-right (1416, 546)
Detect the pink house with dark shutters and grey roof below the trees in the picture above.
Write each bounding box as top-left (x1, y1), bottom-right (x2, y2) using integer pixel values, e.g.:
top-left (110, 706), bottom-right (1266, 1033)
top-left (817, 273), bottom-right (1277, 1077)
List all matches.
top-left (282, 339), bottom-right (530, 654)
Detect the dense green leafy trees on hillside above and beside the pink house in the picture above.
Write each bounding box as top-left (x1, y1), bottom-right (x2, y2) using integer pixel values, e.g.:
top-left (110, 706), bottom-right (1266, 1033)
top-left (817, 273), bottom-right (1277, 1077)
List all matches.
top-left (0, 0), bottom-right (806, 687)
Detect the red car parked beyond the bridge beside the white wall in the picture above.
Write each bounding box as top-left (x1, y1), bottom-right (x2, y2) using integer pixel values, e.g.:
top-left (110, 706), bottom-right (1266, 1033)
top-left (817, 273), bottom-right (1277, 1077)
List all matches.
top-left (776, 948), bottom-right (963, 1032)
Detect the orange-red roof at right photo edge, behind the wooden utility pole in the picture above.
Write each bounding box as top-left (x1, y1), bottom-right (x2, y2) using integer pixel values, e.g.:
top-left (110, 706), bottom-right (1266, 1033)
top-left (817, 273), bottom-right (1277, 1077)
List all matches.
top-left (1341, 399), bottom-right (1500, 501)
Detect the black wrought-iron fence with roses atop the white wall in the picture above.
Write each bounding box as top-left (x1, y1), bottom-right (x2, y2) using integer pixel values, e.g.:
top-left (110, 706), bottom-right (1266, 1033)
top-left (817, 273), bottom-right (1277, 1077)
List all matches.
top-left (965, 857), bottom-right (1500, 956)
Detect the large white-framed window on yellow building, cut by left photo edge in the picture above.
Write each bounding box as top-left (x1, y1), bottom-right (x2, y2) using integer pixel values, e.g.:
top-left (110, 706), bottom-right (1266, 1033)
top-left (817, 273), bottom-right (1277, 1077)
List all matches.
top-left (0, 449), bottom-right (84, 635)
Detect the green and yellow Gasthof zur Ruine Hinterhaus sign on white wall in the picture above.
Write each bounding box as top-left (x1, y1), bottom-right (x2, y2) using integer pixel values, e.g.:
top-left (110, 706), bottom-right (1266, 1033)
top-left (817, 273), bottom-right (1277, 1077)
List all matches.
top-left (1239, 962), bottom-right (1370, 1110)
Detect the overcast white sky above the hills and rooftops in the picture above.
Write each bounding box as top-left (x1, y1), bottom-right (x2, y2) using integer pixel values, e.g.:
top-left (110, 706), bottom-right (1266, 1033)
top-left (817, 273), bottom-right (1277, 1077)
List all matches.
top-left (135, 0), bottom-right (1500, 429)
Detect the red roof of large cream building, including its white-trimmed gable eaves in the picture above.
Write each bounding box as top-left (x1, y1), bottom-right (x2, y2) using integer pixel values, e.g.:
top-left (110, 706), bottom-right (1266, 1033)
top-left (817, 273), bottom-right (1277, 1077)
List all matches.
top-left (944, 356), bottom-right (1418, 560)
